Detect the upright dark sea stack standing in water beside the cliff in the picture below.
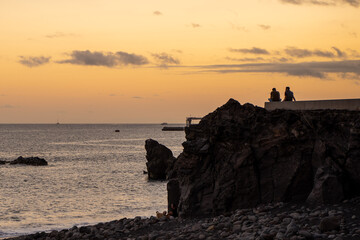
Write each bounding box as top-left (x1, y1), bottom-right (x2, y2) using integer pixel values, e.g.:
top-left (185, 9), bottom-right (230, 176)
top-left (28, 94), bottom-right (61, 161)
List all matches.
top-left (145, 139), bottom-right (176, 180)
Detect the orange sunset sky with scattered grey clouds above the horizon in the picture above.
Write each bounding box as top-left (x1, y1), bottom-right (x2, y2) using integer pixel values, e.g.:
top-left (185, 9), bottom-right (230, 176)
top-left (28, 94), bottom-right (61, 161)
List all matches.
top-left (0, 0), bottom-right (360, 123)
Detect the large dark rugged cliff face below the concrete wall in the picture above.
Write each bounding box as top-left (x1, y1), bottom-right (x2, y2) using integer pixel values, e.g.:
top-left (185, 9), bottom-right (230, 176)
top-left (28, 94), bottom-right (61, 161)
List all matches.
top-left (168, 99), bottom-right (360, 217)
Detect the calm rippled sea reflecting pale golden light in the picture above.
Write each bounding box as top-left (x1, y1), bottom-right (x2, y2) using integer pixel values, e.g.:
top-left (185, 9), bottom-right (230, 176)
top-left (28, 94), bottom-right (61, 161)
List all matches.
top-left (0, 124), bottom-right (185, 238)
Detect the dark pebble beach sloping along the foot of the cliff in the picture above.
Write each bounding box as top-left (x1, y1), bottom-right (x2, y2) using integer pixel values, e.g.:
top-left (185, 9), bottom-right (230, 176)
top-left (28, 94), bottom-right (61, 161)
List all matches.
top-left (7, 198), bottom-right (360, 240)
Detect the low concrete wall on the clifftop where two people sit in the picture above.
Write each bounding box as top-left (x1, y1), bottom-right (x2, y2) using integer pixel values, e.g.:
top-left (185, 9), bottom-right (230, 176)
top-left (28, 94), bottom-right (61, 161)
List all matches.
top-left (265, 98), bottom-right (360, 111)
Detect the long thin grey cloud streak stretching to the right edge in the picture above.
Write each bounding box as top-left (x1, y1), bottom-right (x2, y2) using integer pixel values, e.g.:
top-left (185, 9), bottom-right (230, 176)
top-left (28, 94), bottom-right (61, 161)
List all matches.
top-left (195, 60), bottom-right (360, 78)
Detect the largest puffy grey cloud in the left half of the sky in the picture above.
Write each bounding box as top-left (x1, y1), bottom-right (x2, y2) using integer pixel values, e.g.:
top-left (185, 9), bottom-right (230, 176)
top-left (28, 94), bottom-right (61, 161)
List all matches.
top-left (58, 50), bottom-right (149, 67)
